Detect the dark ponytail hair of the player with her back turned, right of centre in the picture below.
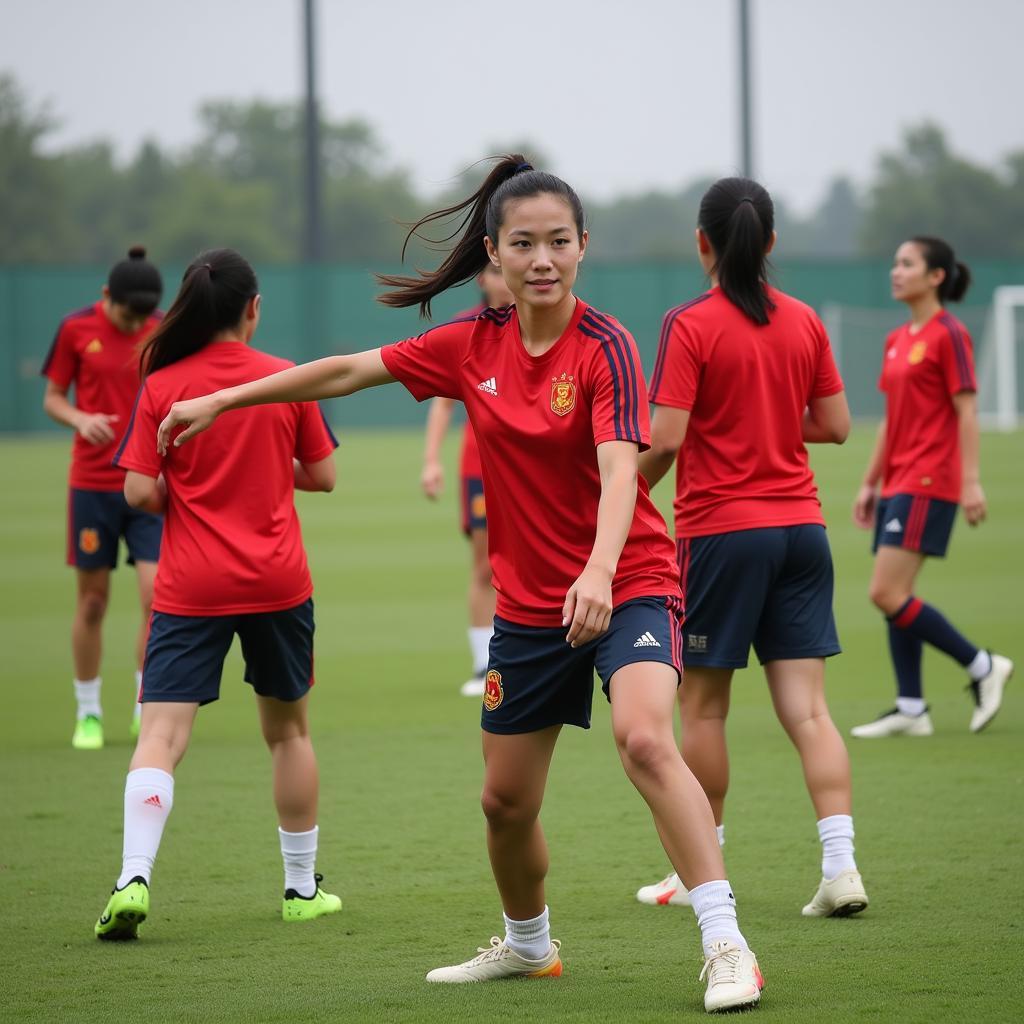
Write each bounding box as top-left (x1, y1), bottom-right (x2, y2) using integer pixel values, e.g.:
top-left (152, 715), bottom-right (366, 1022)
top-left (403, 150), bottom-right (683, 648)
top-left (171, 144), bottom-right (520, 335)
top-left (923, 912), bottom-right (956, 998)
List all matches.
top-left (697, 178), bottom-right (775, 326)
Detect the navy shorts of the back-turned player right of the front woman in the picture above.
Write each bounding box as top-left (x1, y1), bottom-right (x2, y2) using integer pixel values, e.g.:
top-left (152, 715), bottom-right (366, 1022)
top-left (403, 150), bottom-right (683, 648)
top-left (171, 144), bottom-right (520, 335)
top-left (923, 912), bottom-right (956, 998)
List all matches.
top-left (676, 524), bottom-right (842, 669)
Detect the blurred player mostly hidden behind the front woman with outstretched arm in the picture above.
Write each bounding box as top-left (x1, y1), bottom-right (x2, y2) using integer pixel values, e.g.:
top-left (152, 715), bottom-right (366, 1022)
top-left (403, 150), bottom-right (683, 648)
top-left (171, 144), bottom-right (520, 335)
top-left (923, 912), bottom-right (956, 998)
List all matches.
top-left (420, 264), bottom-right (515, 697)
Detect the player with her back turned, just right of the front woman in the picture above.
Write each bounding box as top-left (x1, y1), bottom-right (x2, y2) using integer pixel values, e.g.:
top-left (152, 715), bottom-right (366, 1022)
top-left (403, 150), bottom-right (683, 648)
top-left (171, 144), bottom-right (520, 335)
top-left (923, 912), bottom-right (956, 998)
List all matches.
top-left (637, 178), bottom-right (867, 918)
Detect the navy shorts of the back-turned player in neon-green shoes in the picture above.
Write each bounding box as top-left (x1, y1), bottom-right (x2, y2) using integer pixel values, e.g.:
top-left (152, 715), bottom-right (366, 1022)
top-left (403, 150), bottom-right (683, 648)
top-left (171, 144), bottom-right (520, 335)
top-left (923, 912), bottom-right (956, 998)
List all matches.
top-left (139, 598), bottom-right (314, 705)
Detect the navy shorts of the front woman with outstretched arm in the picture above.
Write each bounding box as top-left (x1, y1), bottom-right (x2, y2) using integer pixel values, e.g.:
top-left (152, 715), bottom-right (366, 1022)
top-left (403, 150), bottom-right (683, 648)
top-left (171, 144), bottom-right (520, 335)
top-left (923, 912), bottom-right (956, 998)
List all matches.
top-left (480, 597), bottom-right (682, 733)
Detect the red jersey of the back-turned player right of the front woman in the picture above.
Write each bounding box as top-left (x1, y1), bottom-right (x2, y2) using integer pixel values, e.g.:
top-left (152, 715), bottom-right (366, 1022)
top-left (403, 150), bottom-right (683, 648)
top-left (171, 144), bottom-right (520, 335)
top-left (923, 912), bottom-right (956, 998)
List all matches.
top-left (650, 288), bottom-right (843, 537)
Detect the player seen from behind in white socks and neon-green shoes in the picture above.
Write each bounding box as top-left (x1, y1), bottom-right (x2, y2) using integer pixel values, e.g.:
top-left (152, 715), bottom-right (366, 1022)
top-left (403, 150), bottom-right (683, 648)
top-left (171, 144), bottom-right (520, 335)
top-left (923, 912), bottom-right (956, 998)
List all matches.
top-left (95, 249), bottom-right (341, 939)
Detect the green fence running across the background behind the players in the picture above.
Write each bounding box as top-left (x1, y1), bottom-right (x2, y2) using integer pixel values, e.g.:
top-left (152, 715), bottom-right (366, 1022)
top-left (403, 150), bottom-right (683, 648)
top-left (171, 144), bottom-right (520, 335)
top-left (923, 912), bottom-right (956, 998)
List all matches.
top-left (0, 261), bottom-right (1024, 432)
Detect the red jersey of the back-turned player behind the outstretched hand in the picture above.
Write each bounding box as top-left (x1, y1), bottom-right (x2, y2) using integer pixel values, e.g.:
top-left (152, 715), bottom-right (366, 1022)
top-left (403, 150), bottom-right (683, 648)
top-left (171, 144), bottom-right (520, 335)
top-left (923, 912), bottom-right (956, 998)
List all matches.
top-left (116, 341), bottom-right (337, 615)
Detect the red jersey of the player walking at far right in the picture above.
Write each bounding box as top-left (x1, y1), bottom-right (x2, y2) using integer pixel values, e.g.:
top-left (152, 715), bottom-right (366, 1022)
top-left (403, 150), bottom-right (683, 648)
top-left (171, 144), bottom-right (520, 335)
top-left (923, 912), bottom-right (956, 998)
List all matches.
top-left (879, 309), bottom-right (978, 502)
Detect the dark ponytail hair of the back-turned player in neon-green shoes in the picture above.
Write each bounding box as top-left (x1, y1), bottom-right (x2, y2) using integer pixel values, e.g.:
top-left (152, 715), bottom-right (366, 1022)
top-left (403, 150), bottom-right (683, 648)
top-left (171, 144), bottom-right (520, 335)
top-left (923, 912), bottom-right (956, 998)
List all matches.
top-left (142, 249), bottom-right (259, 376)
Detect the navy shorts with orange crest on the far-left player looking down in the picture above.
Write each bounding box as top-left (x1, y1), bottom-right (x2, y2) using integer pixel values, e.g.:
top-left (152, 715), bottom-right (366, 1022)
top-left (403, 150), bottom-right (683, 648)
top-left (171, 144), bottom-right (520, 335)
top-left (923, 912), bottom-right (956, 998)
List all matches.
top-left (68, 487), bottom-right (164, 569)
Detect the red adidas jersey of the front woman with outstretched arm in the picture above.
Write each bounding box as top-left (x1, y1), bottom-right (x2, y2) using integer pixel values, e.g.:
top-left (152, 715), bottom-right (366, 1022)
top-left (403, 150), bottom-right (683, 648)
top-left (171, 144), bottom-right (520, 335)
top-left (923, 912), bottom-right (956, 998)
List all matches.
top-left (381, 300), bottom-right (679, 627)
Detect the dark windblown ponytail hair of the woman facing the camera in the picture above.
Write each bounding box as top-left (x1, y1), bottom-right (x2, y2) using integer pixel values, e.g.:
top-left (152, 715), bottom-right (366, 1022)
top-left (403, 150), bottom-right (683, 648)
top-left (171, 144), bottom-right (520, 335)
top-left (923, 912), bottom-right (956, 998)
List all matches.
top-left (377, 153), bottom-right (586, 317)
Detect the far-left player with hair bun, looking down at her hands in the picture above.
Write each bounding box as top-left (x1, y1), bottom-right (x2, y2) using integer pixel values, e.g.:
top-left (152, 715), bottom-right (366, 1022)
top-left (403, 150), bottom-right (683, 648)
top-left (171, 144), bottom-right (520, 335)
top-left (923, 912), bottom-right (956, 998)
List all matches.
top-left (42, 246), bottom-right (164, 751)
